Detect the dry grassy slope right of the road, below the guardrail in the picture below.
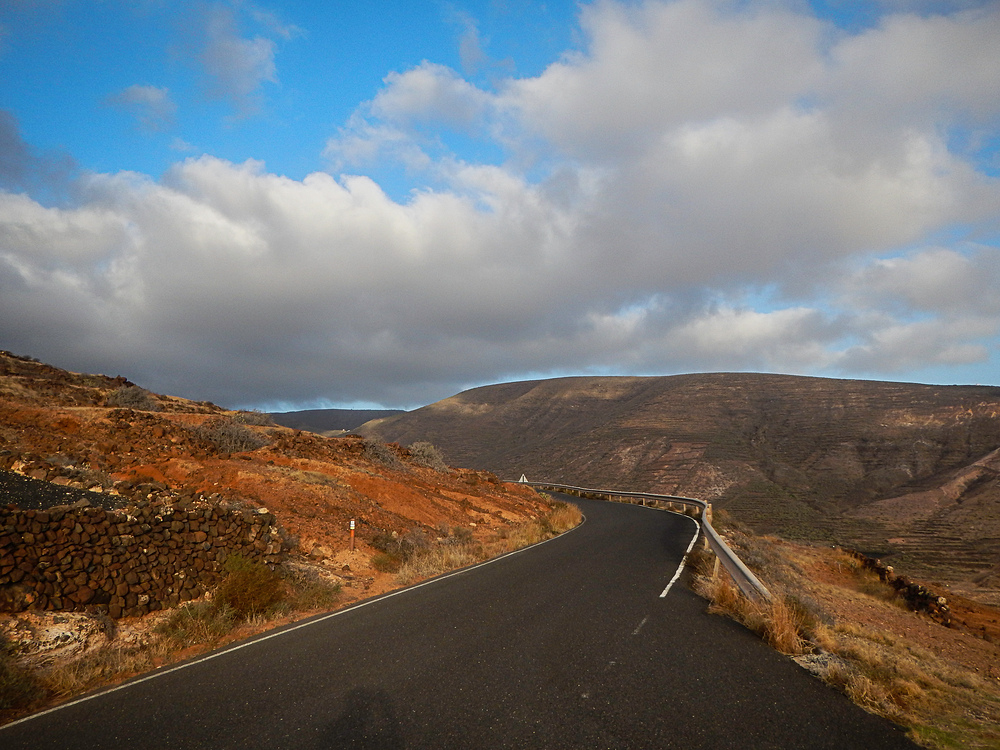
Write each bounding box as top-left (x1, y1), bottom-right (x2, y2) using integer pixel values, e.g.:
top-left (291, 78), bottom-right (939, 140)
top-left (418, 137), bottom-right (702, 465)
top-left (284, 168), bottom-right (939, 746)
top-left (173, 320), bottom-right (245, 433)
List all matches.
top-left (689, 512), bottom-right (1000, 750)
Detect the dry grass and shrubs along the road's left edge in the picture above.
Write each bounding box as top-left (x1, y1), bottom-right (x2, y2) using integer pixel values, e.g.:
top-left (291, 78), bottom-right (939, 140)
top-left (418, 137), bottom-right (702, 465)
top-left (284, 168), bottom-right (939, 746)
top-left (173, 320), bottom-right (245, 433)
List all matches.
top-left (0, 502), bottom-right (582, 723)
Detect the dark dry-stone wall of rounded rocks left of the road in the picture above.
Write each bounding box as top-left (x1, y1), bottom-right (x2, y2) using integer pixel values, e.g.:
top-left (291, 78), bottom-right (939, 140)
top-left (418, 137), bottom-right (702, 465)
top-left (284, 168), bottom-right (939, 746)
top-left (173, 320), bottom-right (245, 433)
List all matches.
top-left (0, 504), bottom-right (283, 618)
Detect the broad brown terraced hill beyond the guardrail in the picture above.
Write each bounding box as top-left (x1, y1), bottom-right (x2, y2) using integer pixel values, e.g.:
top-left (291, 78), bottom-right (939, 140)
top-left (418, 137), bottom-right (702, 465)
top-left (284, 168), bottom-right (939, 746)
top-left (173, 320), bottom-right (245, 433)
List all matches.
top-left (359, 373), bottom-right (1000, 596)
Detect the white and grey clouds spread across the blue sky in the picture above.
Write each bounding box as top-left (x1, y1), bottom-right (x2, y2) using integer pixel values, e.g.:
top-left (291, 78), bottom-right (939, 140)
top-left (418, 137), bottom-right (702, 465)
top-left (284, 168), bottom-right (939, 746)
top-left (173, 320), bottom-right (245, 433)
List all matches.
top-left (0, 0), bottom-right (1000, 407)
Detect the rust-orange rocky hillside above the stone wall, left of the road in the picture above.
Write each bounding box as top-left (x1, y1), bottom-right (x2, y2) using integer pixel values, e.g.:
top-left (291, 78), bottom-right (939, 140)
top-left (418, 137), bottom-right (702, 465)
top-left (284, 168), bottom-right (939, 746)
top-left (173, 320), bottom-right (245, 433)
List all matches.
top-left (0, 352), bottom-right (547, 590)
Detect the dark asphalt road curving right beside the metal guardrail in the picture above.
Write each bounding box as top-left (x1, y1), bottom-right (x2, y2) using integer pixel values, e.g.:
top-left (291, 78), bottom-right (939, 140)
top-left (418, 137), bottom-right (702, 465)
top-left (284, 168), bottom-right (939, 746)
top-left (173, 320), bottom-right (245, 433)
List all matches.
top-left (0, 500), bottom-right (915, 750)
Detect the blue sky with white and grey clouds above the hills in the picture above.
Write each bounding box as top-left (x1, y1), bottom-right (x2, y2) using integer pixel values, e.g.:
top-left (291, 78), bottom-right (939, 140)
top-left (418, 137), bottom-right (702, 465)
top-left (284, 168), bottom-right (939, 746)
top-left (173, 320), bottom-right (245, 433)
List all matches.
top-left (0, 0), bottom-right (1000, 411)
